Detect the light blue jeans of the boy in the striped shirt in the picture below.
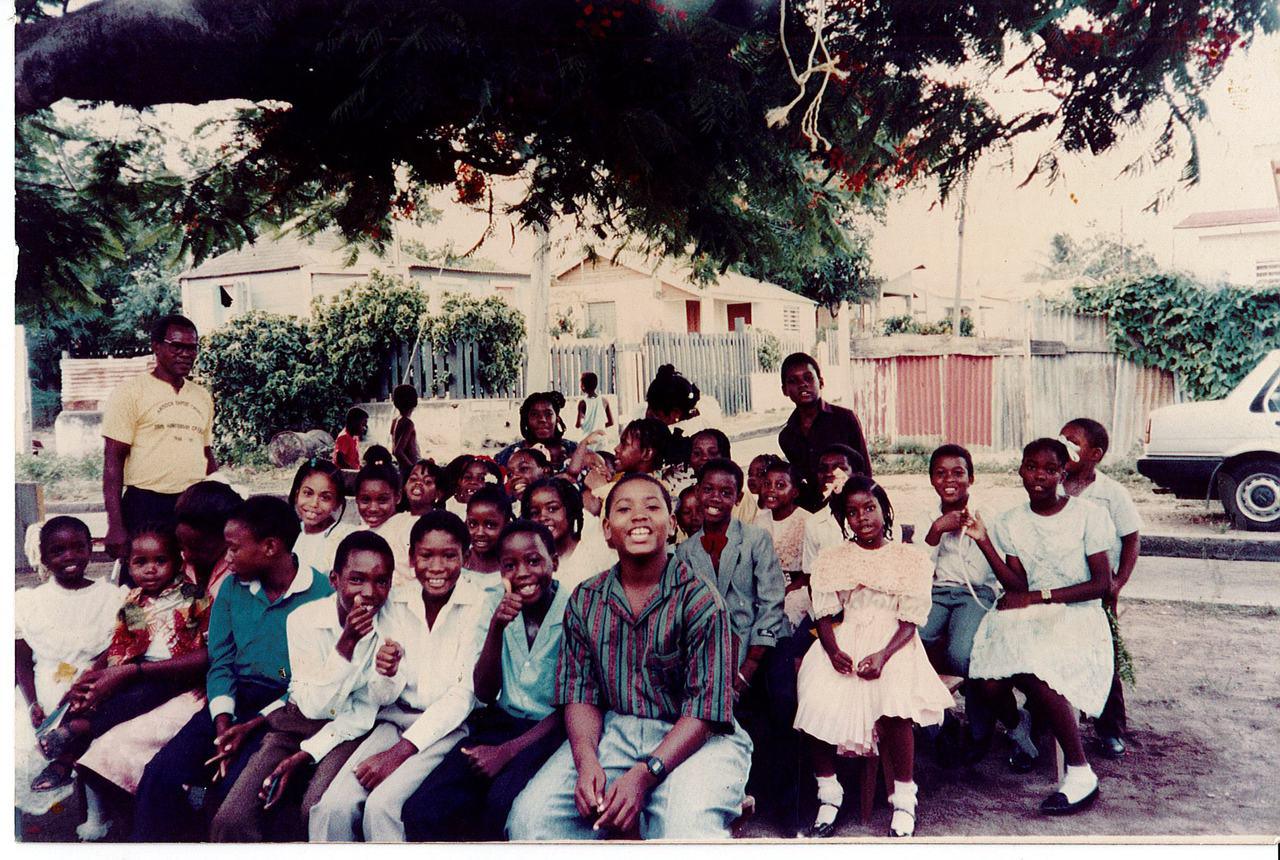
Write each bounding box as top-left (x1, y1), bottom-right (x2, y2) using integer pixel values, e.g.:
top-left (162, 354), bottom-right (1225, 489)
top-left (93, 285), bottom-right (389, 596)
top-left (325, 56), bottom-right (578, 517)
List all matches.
top-left (507, 712), bottom-right (751, 841)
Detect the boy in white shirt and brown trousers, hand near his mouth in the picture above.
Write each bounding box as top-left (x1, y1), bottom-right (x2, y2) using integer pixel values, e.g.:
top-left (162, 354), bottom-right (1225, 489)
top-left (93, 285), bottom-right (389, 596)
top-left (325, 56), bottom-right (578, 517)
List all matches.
top-left (210, 531), bottom-right (404, 842)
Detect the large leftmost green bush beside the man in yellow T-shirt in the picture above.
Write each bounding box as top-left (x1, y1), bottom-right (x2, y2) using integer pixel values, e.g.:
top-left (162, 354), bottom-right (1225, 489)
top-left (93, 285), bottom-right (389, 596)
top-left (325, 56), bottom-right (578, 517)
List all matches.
top-left (196, 311), bottom-right (347, 459)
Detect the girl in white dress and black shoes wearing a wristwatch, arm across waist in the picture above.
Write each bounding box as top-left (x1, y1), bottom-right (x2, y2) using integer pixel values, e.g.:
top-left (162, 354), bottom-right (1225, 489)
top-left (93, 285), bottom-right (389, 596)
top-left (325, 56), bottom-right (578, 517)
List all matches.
top-left (965, 439), bottom-right (1115, 815)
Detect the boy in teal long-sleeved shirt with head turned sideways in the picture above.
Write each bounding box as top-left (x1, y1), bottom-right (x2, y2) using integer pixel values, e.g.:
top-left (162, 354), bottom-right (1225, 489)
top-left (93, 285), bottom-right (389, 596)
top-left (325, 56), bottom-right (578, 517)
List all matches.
top-left (132, 495), bottom-right (333, 842)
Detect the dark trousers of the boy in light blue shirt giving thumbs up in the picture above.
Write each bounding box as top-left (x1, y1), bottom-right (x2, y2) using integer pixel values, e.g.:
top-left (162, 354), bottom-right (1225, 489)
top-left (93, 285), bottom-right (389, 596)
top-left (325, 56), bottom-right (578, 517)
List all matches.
top-left (401, 705), bottom-right (566, 842)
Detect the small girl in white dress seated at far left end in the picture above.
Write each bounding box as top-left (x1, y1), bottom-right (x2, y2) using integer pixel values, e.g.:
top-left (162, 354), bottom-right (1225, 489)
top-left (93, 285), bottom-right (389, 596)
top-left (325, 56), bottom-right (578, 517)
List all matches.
top-left (13, 517), bottom-right (128, 815)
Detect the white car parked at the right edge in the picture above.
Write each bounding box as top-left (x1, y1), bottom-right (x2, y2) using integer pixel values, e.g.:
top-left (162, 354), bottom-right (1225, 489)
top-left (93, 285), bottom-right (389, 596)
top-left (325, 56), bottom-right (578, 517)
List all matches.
top-left (1138, 349), bottom-right (1280, 531)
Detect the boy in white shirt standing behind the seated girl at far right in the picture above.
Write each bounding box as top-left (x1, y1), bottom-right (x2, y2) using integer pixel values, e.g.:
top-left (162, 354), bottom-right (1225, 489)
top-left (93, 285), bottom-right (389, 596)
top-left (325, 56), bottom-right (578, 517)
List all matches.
top-left (1060, 418), bottom-right (1142, 759)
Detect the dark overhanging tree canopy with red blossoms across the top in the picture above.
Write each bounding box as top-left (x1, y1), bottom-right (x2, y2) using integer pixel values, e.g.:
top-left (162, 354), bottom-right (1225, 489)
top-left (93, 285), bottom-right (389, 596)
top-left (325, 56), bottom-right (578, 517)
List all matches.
top-left (15, 0), bottom-right (1277, 309)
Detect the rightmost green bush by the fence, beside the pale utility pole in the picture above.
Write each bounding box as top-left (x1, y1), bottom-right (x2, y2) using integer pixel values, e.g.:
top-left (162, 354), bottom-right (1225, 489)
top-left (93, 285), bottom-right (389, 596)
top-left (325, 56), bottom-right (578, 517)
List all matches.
top-left (426, 293), bottom-right (525, 392)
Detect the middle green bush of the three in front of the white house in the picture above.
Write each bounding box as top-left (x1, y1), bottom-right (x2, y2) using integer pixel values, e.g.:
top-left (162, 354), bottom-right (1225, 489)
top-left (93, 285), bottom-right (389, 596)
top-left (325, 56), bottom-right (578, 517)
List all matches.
top-left (310, 270), bottom-right (428, 399)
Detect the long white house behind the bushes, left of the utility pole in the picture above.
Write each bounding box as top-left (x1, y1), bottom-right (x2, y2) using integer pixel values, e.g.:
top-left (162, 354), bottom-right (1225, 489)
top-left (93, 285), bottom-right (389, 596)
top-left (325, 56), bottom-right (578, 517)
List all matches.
top-left (178, 232), bottom-right (529, 333)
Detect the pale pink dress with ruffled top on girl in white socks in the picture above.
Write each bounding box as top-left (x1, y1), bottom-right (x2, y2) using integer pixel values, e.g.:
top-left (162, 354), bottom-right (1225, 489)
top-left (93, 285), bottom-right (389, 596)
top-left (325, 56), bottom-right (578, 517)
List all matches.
top-left (795, 543), bottom-right (955, 755)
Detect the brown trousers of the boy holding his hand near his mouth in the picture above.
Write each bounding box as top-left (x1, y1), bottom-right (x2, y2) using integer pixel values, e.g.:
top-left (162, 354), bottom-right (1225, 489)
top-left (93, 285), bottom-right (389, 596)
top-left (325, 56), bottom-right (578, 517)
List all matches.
top-left (209, 701), bottom-right (364, 842)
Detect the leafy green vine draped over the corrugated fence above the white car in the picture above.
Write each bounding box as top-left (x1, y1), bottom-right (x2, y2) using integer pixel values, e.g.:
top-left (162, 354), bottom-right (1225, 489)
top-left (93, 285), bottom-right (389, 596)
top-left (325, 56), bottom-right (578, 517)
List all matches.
top-left (1073, 274), bottom-right (1280, 401)
